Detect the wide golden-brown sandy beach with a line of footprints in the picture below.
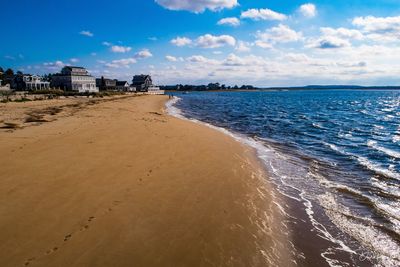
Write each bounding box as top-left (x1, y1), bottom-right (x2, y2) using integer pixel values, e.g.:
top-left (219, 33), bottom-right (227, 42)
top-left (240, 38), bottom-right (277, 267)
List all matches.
top-left (0, 96), bottom-right (291, 266)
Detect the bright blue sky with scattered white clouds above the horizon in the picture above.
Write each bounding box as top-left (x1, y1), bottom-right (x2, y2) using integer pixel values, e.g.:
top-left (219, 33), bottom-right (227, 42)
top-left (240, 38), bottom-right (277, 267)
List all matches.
top-left (0, 0), bottom-right (400, 87)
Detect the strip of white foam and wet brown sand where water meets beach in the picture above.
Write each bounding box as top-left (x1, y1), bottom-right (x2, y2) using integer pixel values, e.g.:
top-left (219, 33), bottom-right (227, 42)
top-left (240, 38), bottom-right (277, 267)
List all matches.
top-left (166, 96), bottom-right (376, 266)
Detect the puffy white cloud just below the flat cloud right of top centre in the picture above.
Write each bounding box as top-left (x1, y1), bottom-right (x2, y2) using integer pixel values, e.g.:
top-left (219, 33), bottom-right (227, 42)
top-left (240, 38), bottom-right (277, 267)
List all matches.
top-left (256, 24), bottom-right (303, 48)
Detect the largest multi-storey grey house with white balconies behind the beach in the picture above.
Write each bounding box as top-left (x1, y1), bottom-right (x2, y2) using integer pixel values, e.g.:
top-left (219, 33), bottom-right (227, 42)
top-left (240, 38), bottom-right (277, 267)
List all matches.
top-left (51, 66), bottom-right (99, 93)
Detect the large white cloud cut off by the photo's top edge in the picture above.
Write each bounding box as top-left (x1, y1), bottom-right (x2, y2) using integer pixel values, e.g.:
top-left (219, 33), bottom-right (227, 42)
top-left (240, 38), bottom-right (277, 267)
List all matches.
top-left (155, 0), bottom-right (238, 13)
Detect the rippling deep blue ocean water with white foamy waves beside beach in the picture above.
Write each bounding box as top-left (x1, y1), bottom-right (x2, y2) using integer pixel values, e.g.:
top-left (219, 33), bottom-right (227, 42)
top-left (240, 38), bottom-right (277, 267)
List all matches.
top-left (168, 90), bottom-right (400, 266)
